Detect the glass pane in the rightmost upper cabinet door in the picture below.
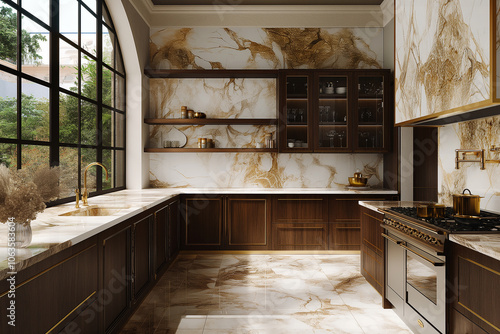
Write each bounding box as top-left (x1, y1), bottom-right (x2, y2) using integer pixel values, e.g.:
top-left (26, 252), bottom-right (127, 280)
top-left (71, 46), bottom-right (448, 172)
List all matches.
top-left (357, 76), bottom-right (384, 149)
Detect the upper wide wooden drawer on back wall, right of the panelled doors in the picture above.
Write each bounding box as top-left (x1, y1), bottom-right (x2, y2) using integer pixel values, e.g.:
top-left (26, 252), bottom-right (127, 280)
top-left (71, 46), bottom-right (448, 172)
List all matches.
top-left (273, 196), bottom-right (328, 223)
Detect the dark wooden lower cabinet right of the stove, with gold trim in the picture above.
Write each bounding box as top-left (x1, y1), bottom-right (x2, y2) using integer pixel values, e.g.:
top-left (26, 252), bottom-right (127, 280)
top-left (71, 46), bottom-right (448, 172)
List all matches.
top-left (446, 242), bottom-right (500, 334)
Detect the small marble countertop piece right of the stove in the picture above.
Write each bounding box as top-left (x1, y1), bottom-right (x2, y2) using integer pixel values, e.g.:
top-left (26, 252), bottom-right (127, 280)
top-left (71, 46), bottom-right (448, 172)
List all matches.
top-left (450, 234), bottom-right (500, 261)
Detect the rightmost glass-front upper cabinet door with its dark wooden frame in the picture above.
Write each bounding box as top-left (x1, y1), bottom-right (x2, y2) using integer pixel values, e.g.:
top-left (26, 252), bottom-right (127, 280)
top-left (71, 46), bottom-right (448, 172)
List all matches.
top-left (353, 72), bottom-right (390, 152)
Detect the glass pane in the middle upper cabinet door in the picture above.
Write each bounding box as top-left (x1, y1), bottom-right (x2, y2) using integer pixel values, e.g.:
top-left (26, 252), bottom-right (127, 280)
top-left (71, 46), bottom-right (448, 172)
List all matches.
top-left (315, 76), bottom-right (349, 149)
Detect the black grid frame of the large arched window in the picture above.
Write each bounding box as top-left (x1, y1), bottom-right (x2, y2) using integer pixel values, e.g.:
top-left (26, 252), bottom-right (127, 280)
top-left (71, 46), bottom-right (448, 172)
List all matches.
top-left (0, 0), bottom-right (127, 206)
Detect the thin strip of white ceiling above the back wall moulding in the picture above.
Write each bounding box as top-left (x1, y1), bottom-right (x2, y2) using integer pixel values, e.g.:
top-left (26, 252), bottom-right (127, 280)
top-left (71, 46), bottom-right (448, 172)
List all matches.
top-left (151, 0), bottom-right (383, 6)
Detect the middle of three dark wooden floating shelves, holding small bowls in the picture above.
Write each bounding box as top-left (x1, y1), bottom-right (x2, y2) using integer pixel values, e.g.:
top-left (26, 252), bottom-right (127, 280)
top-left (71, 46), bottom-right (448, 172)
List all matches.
top-left (144, 118), bottom-right (278, 125)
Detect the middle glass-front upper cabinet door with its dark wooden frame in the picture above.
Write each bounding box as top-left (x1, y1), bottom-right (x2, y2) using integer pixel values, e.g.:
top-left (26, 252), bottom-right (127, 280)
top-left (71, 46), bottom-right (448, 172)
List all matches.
top-left (313, 72), bottom-right (351, 152)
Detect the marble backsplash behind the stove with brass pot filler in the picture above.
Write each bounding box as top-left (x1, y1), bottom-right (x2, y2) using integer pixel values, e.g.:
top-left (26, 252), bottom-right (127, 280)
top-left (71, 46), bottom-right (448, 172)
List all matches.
top-left (438, 116), bottom-right (500, 213)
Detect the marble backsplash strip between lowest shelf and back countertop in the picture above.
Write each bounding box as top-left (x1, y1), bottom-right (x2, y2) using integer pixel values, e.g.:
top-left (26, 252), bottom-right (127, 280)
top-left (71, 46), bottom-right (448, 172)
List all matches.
top-left (150, 153), bottom-right (383, 189)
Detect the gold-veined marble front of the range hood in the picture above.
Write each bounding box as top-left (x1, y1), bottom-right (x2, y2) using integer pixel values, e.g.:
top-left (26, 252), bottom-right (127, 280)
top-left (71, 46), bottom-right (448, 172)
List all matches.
top-left (395, 0), bottom-right (490, 123)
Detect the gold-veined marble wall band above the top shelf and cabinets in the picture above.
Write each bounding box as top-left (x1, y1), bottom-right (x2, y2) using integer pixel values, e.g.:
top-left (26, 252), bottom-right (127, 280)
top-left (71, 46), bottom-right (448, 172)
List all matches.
top-left (150, 27), bottom-right (383, 69)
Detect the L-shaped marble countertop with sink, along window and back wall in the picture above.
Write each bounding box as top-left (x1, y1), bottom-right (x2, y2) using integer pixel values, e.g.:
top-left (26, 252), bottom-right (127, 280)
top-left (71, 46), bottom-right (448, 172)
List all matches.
top-left (0, 188), bottom-right (397, 279)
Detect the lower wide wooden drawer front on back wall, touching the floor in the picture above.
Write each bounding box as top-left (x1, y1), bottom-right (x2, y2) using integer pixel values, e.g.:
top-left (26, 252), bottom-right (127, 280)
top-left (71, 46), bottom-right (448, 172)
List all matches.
top-left (273, 223), bottom-right (328, 250)
